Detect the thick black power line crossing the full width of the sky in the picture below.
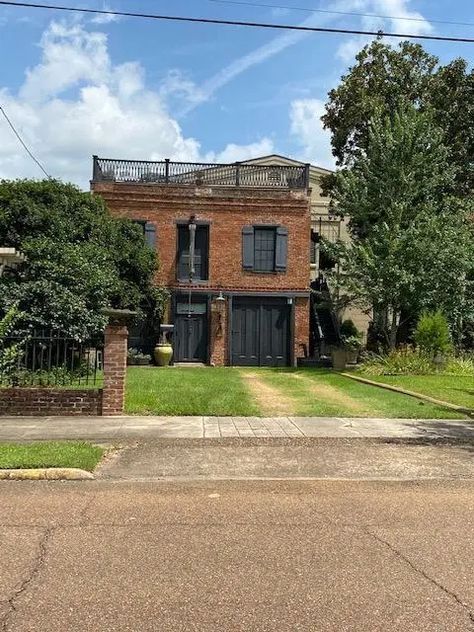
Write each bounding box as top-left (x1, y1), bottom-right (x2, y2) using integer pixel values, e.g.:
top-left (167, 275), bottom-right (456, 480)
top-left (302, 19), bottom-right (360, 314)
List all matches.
top-left (0, 0), bottom-right (474, 44)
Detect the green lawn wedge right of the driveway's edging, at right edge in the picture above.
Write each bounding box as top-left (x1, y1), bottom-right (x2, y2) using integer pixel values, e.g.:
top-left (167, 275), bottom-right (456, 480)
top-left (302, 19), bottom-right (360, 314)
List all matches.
top-left (364, 375), bottom-right (474, 410)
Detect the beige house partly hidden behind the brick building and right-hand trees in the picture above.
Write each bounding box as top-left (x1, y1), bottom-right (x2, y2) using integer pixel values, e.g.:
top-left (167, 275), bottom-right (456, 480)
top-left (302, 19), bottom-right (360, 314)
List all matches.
top-left (244, 154), bottom-right (370, 344)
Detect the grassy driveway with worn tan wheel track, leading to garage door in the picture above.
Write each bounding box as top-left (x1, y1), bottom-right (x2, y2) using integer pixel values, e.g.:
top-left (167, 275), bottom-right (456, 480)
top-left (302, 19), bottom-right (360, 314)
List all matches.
top-left (254, 368), bottom-right (463, 419)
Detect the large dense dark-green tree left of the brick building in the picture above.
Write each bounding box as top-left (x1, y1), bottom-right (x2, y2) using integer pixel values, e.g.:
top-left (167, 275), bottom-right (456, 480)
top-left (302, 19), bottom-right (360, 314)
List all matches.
top-left (0, 180), bottom-right (167, 338)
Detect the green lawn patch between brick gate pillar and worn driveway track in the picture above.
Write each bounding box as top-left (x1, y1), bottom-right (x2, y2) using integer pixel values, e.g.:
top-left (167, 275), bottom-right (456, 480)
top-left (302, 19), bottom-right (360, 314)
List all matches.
top-left (125, 367), bottom-right (260, 416)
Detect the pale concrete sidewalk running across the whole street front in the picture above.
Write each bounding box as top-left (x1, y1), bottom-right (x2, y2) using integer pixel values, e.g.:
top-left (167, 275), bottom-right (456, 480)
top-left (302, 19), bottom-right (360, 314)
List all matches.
top-left (0, 416), bottom-right (474, 443)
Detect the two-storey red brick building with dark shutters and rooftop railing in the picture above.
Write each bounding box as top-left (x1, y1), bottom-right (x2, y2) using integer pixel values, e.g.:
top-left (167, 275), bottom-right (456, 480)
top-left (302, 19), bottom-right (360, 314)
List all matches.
top-left (91, 157), bottom-right (311, 366)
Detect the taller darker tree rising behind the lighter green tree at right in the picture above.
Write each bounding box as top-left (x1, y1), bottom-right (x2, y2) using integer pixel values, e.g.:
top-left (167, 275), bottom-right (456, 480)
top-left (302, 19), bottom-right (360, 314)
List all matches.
top-left (322, 38), bottom-right (474, 194)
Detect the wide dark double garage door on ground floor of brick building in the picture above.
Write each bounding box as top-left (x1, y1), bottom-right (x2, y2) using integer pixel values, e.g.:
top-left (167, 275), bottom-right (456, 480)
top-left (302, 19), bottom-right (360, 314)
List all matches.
top-left (232, 298), bottom-right (290, 366)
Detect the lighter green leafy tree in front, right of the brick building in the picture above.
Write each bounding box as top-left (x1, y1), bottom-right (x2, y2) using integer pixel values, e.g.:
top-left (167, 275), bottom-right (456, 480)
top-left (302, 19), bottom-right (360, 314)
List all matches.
top-left (334, 105), bottom-right (474, 347)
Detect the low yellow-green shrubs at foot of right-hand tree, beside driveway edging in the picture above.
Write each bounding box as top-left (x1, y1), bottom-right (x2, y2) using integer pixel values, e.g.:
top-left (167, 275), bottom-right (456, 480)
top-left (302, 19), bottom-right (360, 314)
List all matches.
top-left (359, 347), bottom-right (436, 375)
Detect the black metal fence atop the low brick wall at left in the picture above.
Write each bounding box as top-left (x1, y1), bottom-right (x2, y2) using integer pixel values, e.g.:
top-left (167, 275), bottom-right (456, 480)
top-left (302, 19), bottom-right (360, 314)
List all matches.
top-left (0, 330), bottom-right (104, 387)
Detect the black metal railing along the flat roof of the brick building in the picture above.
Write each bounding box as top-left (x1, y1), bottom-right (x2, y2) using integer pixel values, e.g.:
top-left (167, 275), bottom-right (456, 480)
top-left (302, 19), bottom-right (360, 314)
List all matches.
top-left (92, 156), bottom-right (310, 189)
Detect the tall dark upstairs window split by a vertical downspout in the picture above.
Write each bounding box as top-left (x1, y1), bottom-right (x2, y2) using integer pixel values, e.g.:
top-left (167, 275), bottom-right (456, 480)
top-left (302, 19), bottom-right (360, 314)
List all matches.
top-left (177, 224), bottom-right (209, 281)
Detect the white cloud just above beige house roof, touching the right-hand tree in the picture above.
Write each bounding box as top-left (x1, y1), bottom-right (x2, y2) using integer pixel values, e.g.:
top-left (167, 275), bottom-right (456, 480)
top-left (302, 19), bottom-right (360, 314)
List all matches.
top-left (290, 99), bottom-right (335, 169)
